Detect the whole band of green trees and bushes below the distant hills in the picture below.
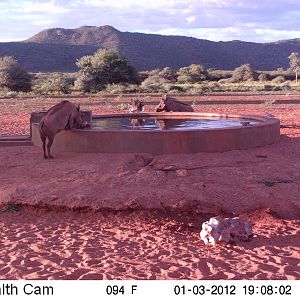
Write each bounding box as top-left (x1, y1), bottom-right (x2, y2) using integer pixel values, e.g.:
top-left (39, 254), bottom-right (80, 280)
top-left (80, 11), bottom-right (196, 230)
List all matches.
top-left (0, 49), bottom-right (300, 96)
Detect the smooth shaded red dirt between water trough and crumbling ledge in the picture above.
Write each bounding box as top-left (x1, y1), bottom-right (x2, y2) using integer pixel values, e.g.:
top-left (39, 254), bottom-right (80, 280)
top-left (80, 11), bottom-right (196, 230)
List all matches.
top-left (0, 136), bottom-right (300, 218)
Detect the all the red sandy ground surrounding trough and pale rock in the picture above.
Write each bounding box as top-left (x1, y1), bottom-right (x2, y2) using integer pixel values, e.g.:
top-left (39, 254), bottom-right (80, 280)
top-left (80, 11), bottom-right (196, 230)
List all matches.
top-left (0, 95), bottom-right (300, 279)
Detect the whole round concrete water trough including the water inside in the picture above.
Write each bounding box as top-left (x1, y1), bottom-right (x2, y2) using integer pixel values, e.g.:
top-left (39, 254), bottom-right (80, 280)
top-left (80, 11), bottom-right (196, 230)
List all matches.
top-left (32, 112), bottom-right (280, 154)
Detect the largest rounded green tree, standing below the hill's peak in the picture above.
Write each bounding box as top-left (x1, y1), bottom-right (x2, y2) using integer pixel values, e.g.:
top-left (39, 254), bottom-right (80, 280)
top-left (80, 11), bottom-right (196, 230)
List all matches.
top-left (75, 49), bottom-right (138, 91)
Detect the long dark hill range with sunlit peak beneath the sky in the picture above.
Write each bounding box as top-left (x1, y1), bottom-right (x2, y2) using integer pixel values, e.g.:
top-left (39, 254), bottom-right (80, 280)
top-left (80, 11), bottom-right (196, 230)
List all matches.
top-left (0, 26), bottom-right (300, 72)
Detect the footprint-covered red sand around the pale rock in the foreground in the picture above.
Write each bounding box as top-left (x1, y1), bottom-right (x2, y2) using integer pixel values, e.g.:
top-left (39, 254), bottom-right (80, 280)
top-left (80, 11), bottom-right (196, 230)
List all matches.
top-left (0, 208), bottom-right (300, 279)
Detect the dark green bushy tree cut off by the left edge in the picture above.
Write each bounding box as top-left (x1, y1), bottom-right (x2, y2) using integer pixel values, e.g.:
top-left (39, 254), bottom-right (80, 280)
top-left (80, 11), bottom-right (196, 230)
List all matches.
top-left (0, 56), bottom-right (32, 92)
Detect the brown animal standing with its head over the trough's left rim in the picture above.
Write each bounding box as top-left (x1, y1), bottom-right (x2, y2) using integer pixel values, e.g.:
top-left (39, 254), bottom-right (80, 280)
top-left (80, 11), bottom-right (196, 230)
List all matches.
top-left (39, 100), bottom-right (85, 158)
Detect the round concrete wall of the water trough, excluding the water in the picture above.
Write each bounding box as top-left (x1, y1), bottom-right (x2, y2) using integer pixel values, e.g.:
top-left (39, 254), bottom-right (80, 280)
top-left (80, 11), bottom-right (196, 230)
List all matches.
top-left (32, 113), bottom-right (280, 154)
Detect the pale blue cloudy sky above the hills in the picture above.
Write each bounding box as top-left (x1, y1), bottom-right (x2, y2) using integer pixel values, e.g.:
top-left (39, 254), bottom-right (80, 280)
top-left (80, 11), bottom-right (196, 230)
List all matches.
top-left (0, 0), bottom-right (300, 42)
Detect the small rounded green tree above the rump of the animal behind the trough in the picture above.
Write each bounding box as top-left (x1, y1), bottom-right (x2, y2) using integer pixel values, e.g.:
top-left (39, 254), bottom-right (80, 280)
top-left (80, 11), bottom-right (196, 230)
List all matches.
top-left (177, 64), bottom-right (208, 83)
